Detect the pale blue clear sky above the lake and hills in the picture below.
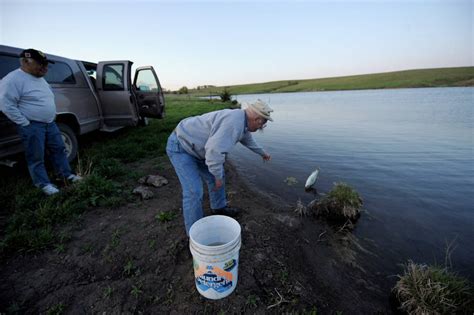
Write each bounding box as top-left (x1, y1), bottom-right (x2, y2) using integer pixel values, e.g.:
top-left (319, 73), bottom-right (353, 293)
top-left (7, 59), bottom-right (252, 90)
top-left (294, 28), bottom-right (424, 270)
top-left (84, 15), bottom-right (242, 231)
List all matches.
top-left (0, 0), bottom-right (474, 90)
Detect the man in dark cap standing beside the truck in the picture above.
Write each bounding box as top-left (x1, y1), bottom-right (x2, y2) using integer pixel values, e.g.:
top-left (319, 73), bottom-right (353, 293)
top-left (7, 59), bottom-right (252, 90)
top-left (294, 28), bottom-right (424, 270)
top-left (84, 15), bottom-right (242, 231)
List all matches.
top-left (0, 49), bottom-right (81, 195)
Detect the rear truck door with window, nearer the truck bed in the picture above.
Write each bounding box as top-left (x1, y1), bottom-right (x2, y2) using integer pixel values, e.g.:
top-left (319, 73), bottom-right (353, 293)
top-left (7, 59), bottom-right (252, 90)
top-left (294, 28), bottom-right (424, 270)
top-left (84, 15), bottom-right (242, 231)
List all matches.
top-left (96, 60), bottom-right (139, 126)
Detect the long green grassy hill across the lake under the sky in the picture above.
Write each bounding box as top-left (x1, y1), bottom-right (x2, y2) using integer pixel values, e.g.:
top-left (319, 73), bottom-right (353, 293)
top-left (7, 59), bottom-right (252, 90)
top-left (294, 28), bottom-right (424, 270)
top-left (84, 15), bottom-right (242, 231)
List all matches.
top-left (189, 67), bottom-right (474, 95)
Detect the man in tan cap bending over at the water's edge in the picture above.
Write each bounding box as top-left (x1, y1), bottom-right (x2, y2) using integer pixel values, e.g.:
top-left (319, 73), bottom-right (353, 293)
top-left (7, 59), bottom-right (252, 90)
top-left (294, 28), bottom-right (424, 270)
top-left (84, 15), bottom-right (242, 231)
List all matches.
top-left (166, 100), bottom-right (273, 235)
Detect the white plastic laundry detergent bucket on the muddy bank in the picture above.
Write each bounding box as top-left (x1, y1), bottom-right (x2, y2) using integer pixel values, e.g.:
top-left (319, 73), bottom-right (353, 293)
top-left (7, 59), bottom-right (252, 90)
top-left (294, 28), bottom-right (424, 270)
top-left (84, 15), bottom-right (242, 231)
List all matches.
top-left (189, 215), bottom-right (241, 300)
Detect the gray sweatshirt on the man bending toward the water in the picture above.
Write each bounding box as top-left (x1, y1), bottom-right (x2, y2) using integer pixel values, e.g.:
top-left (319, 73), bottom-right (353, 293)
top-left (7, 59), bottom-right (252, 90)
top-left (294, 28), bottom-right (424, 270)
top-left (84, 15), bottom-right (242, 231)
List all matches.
top-left (176, 109), bottom-right (265, 179)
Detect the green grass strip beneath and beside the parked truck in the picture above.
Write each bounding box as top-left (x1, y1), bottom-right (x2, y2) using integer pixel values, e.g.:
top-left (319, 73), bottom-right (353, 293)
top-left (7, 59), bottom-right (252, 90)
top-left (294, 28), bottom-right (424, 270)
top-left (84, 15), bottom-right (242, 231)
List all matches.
top-left (0, 96), bottom-right (229, 258)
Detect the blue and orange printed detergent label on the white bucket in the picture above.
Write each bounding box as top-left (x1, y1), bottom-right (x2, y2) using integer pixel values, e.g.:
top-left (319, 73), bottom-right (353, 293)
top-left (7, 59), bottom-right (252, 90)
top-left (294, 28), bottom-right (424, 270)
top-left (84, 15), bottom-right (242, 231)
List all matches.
top-left (196, 265), bottom-right (233, 293)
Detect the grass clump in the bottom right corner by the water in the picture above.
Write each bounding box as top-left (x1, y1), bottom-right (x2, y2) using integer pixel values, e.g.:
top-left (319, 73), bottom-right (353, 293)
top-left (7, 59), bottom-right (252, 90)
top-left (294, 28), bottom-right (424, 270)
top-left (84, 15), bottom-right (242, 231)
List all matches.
top-left (393, 261), bottom-right (474, 315)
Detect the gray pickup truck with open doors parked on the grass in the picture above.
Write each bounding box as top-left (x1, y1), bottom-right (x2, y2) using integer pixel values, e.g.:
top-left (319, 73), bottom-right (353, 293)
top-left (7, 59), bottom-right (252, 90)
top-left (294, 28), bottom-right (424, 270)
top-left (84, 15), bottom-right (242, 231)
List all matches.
top-left (0, 45), bottom-right (165, 164)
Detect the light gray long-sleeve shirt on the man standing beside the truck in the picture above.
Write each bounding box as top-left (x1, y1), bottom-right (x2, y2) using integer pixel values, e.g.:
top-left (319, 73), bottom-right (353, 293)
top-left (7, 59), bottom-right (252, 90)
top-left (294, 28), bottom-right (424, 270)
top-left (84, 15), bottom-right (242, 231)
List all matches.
top-left (0, 69), bottom-right (56, 126)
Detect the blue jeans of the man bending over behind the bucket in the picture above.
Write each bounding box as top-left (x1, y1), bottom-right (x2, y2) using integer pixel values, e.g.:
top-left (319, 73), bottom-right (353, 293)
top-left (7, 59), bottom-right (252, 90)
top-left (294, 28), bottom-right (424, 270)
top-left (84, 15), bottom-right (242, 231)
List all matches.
top-left (166, 132), bottom-right (227, 235)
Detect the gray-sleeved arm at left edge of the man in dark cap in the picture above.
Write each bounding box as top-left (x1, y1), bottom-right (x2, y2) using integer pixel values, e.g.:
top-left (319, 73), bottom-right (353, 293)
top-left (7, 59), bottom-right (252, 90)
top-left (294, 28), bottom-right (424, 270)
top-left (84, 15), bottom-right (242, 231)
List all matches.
top-left (0, 79), bottom-right (30, 126)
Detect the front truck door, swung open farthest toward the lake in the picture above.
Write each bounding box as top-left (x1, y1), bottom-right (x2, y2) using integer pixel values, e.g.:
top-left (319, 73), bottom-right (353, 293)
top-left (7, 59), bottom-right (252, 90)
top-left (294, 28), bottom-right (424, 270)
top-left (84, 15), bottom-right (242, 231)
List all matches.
top-left (133, 66), bottom-right (165, 118)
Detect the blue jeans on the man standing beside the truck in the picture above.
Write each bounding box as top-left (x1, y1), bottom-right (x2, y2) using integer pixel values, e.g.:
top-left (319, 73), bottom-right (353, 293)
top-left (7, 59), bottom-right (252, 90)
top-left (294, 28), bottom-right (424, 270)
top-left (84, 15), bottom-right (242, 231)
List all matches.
top-left (18, 121), bottom-right (72, 187)
